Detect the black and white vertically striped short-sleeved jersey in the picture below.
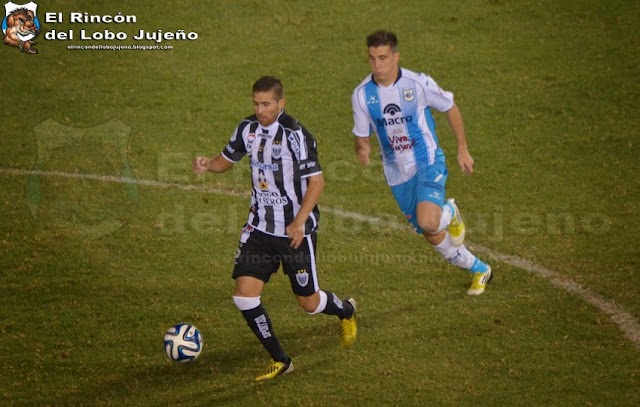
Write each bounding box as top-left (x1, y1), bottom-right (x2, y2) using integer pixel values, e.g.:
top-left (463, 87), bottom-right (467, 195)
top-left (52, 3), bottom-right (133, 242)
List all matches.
top-left (222, 111), bottom-right (322, 237)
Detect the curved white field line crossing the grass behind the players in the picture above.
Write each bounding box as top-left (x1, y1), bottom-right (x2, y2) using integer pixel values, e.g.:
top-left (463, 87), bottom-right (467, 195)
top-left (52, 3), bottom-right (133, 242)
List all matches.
top-left (0, 168), bottom-right (640, 349)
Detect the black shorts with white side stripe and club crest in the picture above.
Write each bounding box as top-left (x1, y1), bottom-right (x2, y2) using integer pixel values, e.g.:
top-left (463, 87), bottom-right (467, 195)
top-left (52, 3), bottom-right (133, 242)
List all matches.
top-left (232, 225), bottom-right (320, 297)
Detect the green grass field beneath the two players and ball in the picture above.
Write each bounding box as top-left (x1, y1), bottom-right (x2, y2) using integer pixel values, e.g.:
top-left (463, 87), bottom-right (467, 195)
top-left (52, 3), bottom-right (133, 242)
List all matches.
top-left (0, 0), bottom-right (640, 406)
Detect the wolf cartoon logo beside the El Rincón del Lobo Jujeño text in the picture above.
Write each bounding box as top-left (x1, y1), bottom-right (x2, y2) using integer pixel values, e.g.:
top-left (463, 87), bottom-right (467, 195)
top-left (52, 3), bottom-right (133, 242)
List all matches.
top-left (2, 2), bottom-right (40, 54)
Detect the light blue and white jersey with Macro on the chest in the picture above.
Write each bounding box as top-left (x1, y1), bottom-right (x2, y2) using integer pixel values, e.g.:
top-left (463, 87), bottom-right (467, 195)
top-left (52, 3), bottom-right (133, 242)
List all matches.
top-left (351, 68), bottom-right (453, 186)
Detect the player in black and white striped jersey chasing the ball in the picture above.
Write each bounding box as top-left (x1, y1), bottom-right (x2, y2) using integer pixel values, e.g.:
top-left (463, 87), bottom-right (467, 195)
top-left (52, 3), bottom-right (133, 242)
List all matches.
top-left (193, 76), bottom-right (357, 380)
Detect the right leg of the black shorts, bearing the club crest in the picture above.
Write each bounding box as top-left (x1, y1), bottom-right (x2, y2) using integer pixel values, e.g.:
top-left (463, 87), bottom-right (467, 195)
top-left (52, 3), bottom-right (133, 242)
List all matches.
top-left (282, 233), bottom-right (320, 297)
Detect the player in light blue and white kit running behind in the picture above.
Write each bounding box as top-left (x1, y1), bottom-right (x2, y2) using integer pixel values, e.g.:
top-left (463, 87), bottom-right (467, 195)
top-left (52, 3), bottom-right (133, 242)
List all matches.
top-left (351, 31), bottom-right (491, 295)
